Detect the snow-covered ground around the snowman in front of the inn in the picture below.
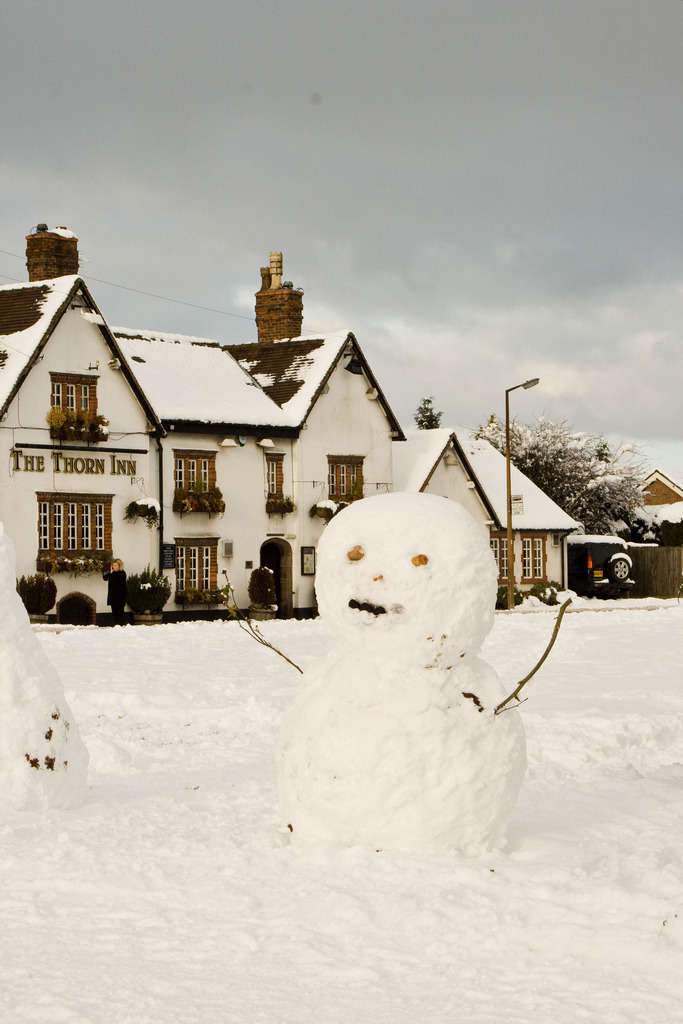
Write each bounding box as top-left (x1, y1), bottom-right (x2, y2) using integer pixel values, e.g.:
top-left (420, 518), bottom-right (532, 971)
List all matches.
top-left (0, 602), bottom-right (683, 1024)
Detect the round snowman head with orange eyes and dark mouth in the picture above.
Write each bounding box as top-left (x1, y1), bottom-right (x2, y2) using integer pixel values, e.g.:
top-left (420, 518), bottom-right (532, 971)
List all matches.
top-left (315, 493), bottom-right (498, 668)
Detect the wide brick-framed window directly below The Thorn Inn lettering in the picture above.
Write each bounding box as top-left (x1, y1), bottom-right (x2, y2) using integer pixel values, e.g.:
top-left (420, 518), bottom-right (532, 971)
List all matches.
top-left (36, 490), bottom-right (113, 554)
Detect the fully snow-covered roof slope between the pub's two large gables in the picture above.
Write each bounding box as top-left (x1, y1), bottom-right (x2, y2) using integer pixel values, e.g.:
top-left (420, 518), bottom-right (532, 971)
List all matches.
top-left (113, 327), bottom-right (292, 427)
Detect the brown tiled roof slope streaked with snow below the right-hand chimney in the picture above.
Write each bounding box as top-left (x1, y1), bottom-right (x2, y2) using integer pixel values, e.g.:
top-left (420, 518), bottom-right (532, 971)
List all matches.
top-left (227, 338), bottom-right (325, 408)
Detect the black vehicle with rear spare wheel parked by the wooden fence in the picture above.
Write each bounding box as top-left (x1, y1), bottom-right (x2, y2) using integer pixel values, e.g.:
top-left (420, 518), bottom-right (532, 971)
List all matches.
top-left (567, 536), bottom-right (636, 597)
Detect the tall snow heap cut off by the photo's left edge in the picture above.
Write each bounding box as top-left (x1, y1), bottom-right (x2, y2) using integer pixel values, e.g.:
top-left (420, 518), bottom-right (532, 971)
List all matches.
top-left (0, 523), bottom-right (88, 810)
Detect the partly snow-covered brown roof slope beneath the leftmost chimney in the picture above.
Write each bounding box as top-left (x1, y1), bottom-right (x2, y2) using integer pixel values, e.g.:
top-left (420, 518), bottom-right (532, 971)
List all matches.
top-left (0, 276), bottom-right (79, 409)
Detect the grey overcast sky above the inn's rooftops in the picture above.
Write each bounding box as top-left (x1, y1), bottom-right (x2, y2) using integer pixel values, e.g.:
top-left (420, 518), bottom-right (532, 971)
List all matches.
top-left (0, 0), bottom-right (683, 472)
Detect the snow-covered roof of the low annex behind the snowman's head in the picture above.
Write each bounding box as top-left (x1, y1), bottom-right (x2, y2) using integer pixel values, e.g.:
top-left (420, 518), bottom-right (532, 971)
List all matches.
top-left (393, 427), bottom-right (579, 530)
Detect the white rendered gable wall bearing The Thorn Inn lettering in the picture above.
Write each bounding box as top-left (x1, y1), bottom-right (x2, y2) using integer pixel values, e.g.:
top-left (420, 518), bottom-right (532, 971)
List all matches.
top-left (0, 309), bottom-right (158, 612)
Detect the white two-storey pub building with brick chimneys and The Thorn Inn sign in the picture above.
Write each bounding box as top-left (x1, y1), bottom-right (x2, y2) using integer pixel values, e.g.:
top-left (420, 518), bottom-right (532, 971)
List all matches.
top-left (0, 224), bottom-right (574, 623)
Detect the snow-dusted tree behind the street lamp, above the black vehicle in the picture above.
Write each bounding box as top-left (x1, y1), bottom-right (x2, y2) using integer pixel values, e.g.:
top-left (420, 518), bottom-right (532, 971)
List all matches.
top-left (477, 416), bottom-right (644, 535)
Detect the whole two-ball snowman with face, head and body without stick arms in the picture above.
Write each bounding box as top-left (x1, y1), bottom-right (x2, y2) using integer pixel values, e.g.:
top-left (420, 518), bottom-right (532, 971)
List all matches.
top-left (279, 493), bottom-right (526, 856)
